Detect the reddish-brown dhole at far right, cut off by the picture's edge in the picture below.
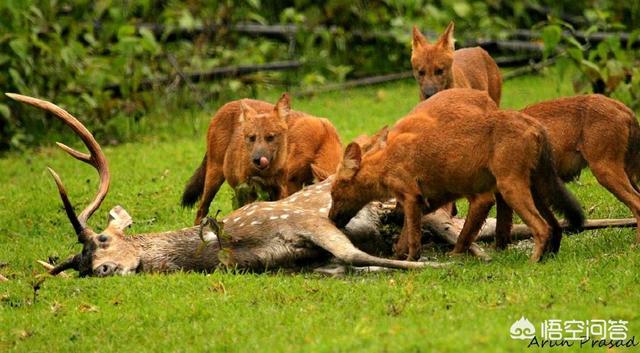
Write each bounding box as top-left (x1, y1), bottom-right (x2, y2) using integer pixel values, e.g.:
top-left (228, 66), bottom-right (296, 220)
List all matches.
top-left (522, 94), bottom-right (640, 241)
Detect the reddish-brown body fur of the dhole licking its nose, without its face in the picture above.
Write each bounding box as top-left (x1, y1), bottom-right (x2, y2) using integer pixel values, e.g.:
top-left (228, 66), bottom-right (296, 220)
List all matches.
top-left (183, 93), bottom-right (342, 224)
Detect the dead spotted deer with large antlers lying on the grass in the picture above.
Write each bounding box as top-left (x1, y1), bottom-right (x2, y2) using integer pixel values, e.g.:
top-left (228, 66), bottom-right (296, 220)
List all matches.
top-left (7, 93), bottom-right (452, 276)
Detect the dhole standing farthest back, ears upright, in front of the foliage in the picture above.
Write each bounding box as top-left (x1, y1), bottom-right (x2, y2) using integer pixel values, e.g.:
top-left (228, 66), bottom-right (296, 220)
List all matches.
top-left (411, 22), bottom-right (502, 105)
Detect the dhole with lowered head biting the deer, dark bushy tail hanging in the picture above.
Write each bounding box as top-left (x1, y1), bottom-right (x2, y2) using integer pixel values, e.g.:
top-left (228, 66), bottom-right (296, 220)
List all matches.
top-left (329, 89), bottom-right (584, 261)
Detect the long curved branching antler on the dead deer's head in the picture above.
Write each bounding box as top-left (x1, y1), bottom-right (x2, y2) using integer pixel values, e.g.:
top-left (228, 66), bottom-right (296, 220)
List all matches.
top-left (6, 93), bottom-right (111, 242)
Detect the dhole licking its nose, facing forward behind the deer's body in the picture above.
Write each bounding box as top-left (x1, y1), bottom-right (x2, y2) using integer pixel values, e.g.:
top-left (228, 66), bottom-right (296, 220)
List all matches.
top-left (182, 93), bottom-right (342, 224)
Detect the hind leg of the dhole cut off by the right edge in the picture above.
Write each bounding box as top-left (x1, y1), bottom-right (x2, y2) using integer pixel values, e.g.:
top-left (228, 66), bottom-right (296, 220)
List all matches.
top-left (589, 161), bottom-right (640, 242)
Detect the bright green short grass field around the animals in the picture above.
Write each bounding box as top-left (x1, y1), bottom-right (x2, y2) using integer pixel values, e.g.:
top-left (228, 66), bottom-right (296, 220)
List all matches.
top-left (0, 70), bottom-right (640, 352)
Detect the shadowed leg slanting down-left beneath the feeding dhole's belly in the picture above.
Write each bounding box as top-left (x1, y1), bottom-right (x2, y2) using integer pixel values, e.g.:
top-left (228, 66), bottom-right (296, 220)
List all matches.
top-left (452, 193), bottom-right (493, 254)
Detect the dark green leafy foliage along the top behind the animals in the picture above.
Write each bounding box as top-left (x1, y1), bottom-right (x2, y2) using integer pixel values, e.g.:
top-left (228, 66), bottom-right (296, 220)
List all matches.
top-left (0, 0), bottom-right (640, 151)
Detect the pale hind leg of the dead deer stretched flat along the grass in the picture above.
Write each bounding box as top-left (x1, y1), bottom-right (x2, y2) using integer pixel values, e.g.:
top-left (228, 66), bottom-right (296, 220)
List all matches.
top-left (301, 226), bottom-right (449, 270)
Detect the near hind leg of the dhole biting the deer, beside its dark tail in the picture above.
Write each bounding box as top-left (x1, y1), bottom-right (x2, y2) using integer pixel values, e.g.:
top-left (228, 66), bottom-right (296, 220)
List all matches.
top-left (498, 178), bottom-right (551, 262)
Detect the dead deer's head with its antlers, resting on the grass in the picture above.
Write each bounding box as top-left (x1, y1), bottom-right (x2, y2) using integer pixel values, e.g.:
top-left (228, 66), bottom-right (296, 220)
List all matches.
top-left (7, 93), bottom-right (140, 276)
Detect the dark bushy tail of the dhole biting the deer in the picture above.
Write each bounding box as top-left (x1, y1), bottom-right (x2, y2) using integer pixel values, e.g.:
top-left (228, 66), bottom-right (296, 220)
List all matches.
top-left (532, 142), bottom-right (584, 230)
